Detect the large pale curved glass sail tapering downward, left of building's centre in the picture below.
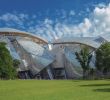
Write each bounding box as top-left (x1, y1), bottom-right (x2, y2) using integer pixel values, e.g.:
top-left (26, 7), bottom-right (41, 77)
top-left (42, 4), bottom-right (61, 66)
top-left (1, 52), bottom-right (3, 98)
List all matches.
top-left (17, 39), bottom-right (54, 72)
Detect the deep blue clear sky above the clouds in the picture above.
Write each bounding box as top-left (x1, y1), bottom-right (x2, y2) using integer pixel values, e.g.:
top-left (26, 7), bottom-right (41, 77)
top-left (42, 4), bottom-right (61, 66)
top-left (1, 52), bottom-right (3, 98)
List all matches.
top-left (0, 0), bottom-right (109, 21)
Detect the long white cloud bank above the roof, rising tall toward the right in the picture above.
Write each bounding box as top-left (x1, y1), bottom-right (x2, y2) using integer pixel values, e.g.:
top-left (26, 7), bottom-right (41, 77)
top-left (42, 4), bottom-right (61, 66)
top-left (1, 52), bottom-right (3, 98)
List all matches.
top-left (23, 5), bottom-right (110, 40)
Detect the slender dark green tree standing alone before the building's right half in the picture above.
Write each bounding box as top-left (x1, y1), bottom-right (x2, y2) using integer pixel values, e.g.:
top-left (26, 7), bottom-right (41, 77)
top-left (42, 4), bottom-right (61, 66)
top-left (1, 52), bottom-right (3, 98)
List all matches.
top-left (75, 47), bottom-right (92, 78)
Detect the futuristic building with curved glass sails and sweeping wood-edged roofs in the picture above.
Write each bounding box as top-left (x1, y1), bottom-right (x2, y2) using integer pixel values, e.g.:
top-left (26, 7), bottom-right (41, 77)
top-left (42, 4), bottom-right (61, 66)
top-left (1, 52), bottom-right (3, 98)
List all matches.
top-left (0, 28), bottom-right (110, 79)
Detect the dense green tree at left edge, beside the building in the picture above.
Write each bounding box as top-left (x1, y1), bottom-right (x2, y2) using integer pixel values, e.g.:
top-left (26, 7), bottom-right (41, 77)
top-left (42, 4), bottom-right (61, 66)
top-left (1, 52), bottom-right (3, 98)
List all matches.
top-left (0, 42), bottom-right (16, 79)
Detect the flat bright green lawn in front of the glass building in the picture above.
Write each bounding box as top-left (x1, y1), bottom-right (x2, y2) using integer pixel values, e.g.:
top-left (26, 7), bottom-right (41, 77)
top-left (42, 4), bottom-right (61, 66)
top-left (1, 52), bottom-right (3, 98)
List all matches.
top-left (0, 80), bottom-right (110, 100)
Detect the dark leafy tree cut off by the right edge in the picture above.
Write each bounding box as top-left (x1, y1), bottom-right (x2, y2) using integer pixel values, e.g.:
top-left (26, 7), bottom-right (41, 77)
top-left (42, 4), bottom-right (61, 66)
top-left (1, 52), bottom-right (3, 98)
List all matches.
top-left (96, 42), bottom-right (110, 73)
